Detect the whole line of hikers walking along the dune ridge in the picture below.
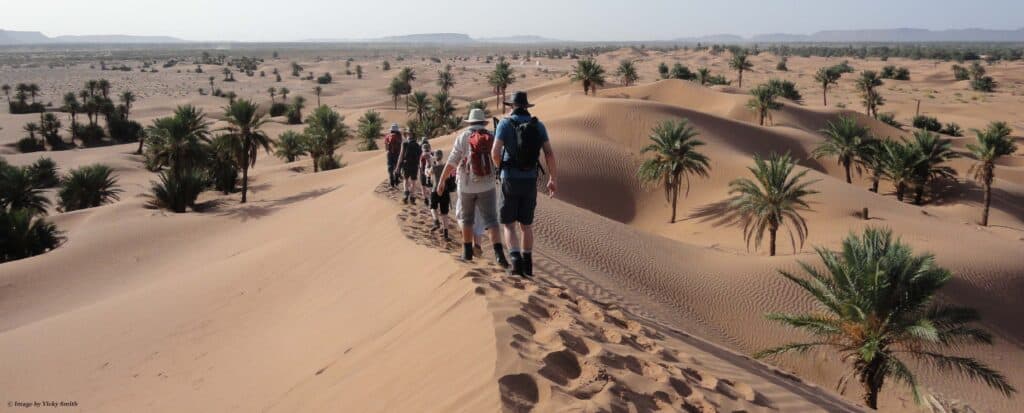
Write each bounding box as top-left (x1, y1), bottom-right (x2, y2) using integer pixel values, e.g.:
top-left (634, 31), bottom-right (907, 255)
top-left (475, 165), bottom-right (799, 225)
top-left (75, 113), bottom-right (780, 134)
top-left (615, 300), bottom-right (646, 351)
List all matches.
top-left (384, 91), bottom-right (558, 277)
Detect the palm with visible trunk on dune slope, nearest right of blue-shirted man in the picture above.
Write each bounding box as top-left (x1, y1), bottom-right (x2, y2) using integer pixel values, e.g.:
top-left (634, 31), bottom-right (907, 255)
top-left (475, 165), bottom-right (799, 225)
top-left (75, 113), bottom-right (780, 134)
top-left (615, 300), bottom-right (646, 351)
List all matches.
top-left (637, 119), bottom-right (711, 223)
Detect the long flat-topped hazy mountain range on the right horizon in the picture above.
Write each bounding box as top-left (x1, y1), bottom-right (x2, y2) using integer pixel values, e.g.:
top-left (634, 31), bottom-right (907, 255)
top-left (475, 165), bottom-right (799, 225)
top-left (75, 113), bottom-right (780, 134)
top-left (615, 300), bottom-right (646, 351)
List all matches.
top-left (674, 29), bottom-right (1024, 43)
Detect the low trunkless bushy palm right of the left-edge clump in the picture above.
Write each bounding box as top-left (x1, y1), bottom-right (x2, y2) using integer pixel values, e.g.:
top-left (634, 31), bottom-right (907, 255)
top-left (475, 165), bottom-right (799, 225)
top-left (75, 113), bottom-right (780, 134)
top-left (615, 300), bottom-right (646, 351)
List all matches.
top-left (57, 164), bottom-right (122, 211)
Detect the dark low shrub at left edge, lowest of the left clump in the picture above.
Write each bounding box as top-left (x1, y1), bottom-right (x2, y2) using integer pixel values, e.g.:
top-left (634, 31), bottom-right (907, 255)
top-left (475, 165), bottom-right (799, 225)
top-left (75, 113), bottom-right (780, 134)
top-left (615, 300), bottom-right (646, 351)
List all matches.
top-left (0, 208), bottom-right (63, 262)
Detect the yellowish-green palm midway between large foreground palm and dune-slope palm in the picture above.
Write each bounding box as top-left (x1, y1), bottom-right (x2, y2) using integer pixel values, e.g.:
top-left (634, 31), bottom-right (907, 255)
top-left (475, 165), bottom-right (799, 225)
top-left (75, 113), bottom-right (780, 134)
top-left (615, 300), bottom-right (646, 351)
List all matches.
top-left (728, 154), bottom-right (818, 256)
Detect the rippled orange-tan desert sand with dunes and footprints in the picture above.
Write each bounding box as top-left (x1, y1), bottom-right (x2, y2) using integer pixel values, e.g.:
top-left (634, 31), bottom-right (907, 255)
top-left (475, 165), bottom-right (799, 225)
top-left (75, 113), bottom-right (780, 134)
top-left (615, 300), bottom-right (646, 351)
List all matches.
top-left (0, 50), bottom-right (1024, 412)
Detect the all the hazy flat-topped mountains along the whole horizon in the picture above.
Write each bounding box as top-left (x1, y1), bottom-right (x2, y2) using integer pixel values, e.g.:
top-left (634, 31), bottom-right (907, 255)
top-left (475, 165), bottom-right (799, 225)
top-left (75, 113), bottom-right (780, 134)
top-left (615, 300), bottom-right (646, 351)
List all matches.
top-left (6, 29), bottom-right (1024, 46)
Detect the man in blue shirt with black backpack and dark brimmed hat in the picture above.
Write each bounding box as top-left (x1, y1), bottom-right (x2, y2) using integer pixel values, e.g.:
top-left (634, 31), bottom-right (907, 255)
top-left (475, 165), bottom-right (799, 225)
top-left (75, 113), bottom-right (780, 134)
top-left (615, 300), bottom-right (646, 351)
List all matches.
top-left (490, 91), bottom-right (558, 277)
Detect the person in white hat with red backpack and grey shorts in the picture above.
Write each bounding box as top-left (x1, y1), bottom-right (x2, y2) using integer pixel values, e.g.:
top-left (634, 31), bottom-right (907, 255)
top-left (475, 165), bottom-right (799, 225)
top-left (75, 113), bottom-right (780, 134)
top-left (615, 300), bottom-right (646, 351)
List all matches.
top-left (437, 109), bottom-right (509, 269)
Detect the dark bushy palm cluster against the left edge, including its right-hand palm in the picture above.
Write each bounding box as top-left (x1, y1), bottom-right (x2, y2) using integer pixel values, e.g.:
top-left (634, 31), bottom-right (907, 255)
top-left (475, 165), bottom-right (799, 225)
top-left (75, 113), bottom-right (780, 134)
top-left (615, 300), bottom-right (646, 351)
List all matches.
top-left (0, 158), bottom-right (121, 262)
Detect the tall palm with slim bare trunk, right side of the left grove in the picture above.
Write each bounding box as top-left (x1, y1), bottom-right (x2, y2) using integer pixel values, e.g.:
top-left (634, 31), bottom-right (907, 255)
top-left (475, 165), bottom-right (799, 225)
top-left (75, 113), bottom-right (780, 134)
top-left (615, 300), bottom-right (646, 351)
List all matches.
top-left (224, 99), bottom-right (270, 204)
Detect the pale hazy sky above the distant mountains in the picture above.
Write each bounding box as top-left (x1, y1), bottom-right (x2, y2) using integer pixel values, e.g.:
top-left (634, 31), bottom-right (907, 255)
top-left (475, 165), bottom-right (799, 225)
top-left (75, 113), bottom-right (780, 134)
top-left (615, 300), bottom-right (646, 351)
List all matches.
top-left (0, 0), bottom-right (1024, 41)
